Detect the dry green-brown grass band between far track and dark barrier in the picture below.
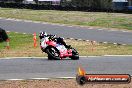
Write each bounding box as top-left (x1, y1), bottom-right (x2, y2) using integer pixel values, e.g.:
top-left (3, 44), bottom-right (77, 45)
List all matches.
top-left (0, 8), bottom-right (132, 30)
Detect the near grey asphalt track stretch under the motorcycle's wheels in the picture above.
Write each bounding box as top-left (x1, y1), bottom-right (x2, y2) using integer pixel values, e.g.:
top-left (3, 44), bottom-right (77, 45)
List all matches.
top-left (0, 56), bottom-right (132, 80)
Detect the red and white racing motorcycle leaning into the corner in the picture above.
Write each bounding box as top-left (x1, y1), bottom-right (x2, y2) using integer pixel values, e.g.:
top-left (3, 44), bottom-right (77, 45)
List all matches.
top-left (40, 37), bottom-right (79, 60)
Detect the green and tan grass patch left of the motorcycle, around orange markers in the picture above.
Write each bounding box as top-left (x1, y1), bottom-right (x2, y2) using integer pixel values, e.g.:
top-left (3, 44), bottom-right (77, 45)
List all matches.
top-left (0, 32), bottom-right (42, 57)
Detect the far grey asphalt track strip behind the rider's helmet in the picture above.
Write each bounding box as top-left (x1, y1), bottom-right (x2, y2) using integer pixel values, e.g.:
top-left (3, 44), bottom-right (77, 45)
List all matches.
top-left (0, 18), bottom-right (132, 44)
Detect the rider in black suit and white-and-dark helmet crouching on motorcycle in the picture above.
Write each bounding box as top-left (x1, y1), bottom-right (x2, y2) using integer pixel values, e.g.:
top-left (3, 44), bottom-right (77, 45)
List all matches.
top-left (39, 31), bottom-right (71, 49)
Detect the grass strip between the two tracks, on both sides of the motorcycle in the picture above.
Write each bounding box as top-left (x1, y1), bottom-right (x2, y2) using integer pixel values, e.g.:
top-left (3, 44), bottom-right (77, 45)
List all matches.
top-left (0, 32), bottom-right (132, 57)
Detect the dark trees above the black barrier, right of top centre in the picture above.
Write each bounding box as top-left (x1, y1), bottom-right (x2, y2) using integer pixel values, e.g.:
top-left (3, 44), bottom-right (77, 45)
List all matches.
top-left (62, 0), bottom-right (112, 9)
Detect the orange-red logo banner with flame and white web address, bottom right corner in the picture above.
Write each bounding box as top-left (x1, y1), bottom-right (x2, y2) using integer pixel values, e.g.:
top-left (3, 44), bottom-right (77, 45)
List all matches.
top-left (76, 67), bottom-right (131, 85)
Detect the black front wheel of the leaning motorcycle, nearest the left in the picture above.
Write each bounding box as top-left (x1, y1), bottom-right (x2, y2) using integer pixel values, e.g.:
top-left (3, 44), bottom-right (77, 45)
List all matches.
top-left (46, 47), bottom-right (60, 60)
